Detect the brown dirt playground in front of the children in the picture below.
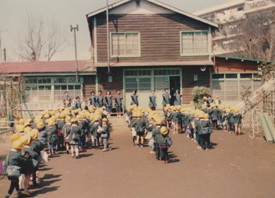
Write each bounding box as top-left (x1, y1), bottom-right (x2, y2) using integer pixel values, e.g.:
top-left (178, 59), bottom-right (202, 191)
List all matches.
top-left (0, 122), bottom-right (275, 198)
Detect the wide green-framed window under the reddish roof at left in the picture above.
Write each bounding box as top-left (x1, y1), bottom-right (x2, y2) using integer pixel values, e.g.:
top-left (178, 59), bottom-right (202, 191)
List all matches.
top-left (24, 76), bottom-right (83, 103)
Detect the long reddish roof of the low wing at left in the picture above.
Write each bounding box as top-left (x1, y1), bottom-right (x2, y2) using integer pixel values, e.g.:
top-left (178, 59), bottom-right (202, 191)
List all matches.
top-left (0, 60), bottom-right (96, 74)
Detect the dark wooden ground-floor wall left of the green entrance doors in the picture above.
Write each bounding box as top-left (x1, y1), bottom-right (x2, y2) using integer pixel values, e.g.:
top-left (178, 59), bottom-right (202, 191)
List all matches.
top-left (97, 68), bottom-right (123, 101)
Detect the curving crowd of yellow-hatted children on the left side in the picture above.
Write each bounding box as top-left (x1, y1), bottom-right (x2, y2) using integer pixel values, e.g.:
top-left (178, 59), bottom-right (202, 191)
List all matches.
top-left (3, 105), bottom-right (111, 198)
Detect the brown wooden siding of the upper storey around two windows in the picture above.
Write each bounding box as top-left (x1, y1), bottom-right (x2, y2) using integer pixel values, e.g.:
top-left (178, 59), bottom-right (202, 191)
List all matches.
top-left (97, 14), bottom-right (209, 63)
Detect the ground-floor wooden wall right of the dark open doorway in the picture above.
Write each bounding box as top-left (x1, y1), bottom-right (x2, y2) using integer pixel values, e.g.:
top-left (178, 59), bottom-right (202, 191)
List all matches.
top-left (182, 66), bottom-right (212, 104)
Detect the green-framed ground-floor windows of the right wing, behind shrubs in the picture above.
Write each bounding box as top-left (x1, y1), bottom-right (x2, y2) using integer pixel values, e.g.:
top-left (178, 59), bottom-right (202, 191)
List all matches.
top-left (211, 72), bottom-right (261, 101)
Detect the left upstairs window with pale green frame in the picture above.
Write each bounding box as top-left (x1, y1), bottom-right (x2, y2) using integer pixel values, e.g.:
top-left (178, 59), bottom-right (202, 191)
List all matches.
top-left (111, 33), bottom-right (140, 57)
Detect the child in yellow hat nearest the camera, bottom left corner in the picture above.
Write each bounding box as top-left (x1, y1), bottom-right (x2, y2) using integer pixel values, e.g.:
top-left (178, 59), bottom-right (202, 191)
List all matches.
top-left (3, 139), bottom-right (29, 198)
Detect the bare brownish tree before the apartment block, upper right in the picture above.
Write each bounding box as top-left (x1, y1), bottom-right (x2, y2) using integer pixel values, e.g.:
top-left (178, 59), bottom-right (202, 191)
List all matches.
top-left (222, 11), bottom-right (275, 61)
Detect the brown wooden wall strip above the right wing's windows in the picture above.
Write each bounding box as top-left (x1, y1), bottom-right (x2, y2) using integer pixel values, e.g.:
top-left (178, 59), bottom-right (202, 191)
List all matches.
top-left (213, 58), bottom-right (260, 73)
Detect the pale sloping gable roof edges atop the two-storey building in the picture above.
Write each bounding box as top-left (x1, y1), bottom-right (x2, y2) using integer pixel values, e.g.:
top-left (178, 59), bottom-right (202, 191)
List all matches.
top-left (86, 0), bottom-right (218, 27)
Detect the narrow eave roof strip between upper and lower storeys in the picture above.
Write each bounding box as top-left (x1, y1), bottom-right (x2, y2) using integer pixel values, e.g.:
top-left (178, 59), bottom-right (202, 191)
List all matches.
top-left (95, 60), bottom-right (214, 67)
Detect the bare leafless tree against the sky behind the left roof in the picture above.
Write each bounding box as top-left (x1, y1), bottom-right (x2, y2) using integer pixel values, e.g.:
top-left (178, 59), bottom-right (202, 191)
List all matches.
top-left (15, 13), bottom-right (68, 61)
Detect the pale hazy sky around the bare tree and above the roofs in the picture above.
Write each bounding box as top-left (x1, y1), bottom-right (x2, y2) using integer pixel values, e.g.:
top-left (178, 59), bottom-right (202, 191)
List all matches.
top-left (0, 0), bottom-right (226, 62)
